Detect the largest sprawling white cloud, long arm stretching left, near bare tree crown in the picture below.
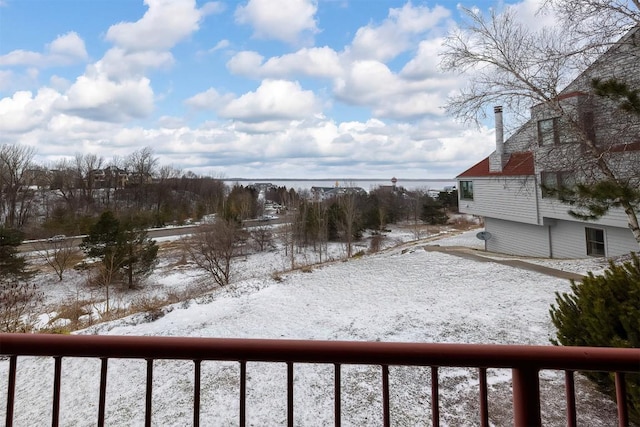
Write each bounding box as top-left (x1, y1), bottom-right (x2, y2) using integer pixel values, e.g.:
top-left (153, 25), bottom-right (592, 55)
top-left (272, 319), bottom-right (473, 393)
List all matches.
top-left (227, 3), bottom-right (458, 119)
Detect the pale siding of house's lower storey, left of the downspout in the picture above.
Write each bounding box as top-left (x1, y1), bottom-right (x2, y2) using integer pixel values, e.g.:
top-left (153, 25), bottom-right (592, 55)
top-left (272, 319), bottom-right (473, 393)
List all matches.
top-left (484, 218), bottom-right (550, 258)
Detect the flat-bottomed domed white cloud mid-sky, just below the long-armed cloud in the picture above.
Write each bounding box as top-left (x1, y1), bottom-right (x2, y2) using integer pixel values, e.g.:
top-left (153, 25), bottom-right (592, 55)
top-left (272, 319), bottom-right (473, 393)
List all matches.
top-left (218, 80), bottom-right (320, 122)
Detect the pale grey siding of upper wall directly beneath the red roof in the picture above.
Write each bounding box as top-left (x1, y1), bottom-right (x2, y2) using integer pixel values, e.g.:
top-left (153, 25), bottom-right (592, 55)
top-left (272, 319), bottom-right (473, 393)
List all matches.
top-left (458, 177), bottom-right (538, 224)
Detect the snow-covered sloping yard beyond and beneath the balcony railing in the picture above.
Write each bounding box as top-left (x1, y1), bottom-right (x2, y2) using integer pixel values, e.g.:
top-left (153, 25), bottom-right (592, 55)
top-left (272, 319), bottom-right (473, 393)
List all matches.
top-left (0, 226), bottom-right (616, 426)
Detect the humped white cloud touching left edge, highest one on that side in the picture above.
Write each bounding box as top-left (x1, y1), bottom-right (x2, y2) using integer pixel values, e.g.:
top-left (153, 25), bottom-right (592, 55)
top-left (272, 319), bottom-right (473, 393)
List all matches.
top-left (0, 31), bottom-right (88, 67)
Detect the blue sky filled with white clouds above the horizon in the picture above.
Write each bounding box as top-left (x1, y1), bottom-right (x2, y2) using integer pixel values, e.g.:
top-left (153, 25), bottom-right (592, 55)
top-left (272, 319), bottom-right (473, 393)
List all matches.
top-left (0, 0), bottom-right (552, 179)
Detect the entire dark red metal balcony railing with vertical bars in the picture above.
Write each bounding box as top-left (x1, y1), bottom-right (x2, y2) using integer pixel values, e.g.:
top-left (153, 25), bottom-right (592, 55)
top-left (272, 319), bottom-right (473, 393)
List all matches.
top-left (0, 334), bottom-right (640, 427)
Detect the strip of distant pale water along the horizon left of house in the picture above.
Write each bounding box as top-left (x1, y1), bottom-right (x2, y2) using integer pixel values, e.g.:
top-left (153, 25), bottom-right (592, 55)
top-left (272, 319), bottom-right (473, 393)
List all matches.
top-left (224, 178), bottom-right (456, 191)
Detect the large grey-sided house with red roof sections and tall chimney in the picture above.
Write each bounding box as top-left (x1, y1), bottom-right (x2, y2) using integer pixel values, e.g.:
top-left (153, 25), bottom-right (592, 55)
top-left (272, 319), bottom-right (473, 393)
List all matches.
top-left (457, 28), bottom-right (640, 258)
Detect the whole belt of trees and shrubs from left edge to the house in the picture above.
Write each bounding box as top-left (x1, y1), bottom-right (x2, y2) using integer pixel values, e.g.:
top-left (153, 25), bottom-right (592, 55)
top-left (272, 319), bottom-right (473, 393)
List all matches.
top-left (0, 145), bottom-right (457, 331)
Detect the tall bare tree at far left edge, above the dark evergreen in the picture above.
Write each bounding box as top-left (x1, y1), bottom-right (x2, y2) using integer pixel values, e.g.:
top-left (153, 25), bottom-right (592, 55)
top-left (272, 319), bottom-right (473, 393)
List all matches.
top-left (0, 144), bottom-right (35, 229)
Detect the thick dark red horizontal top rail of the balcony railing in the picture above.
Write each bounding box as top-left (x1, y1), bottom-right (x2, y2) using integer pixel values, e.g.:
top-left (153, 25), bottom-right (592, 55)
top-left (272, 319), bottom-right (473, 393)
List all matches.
top-left (0, 334), bottom-right (640, 372)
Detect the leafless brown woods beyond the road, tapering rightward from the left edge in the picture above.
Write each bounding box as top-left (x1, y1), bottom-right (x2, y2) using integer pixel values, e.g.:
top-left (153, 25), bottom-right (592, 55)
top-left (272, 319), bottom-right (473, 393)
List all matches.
top-left (0, 144), bottom-right (230, 238)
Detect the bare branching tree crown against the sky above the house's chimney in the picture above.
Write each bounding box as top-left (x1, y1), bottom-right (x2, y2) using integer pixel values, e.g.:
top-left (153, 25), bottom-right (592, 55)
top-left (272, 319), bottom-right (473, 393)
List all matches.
top-left (441, 8), bottom-right (573, 127)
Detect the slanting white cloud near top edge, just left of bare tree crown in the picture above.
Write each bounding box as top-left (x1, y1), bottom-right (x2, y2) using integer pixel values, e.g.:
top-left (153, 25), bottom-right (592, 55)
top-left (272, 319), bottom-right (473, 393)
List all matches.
top-left (349, 3), bottom-right (451, 61)
